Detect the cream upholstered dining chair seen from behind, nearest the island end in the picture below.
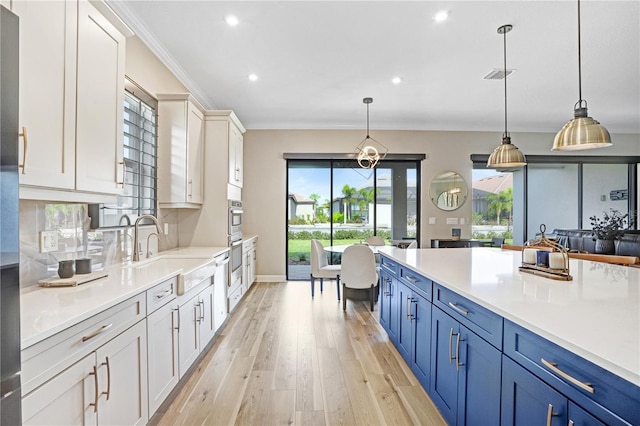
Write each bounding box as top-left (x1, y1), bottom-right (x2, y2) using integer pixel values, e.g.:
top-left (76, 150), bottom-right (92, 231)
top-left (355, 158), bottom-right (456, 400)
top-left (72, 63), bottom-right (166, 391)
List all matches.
top-left (340, 244), bottom-right (378, 311)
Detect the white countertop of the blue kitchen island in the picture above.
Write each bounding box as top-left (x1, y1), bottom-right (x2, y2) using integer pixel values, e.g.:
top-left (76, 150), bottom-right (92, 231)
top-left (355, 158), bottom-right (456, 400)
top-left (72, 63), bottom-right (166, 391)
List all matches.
top-left (380, 247), bottom-right (640, 386)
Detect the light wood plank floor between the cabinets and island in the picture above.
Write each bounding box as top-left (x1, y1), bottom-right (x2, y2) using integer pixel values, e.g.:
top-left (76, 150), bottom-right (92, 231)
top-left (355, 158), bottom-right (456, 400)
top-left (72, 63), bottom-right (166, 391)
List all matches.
top-left (152, 281), bottom-right (446, 425)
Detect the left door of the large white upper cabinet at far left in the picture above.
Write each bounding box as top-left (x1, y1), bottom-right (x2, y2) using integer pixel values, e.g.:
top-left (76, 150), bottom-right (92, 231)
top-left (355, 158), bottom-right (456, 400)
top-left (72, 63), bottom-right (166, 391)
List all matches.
top-left (13, 1), bottom-right (78, 190)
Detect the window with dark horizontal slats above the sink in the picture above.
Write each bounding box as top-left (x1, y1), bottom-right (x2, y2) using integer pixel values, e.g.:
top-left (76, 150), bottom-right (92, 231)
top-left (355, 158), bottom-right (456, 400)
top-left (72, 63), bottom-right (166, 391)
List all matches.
top-left (89, 80), bottom-right (158, 228)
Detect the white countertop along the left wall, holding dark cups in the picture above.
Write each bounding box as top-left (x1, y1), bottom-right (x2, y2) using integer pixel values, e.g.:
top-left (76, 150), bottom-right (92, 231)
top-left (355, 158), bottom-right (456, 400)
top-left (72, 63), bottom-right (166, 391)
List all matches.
top-left (20, 247), bottom-right (229, 349)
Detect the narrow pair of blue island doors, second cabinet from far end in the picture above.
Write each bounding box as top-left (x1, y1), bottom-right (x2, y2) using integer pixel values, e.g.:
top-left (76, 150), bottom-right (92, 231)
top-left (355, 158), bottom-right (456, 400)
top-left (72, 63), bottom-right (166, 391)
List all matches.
top-left (396, 282), bottom-right (431, 389)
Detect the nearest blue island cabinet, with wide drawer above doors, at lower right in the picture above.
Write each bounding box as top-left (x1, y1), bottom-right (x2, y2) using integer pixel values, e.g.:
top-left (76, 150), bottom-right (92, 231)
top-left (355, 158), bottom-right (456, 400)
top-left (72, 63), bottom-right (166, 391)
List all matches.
top-left (502, 321), bottom-right (640, 425)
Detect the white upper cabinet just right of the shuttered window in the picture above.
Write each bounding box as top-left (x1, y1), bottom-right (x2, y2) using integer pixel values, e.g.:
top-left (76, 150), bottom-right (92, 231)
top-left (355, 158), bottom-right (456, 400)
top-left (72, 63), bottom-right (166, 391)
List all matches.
top-left (158, 93), bottom-right (204, 208)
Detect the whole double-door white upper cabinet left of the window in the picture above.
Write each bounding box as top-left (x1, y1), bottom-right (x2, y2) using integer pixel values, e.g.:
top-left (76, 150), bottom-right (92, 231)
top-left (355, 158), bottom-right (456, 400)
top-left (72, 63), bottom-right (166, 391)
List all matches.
top-left (12, 0), bottom-right (126, 201)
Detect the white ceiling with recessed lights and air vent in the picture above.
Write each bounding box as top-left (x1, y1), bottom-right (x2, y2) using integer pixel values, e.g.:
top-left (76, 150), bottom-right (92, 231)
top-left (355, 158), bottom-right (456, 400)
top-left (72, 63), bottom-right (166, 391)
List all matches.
top-left (108, 0), bottom-right (640, 133)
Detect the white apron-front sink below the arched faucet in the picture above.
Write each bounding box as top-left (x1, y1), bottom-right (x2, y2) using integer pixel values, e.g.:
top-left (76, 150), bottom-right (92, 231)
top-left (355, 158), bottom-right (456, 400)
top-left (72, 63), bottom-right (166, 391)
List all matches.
top-left (128, 256), bottom-right (216, 296)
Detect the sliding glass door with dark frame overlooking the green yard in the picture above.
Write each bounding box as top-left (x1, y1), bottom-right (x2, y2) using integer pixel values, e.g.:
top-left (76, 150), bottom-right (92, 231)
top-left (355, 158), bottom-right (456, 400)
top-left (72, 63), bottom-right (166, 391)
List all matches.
top-left (287, 160), bottom-right (420, 280)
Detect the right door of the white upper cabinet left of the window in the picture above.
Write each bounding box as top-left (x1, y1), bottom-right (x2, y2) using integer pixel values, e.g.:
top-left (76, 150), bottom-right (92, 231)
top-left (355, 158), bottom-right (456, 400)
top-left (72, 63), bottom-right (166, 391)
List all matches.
top-left (76, 1), bottom-right (125, 194)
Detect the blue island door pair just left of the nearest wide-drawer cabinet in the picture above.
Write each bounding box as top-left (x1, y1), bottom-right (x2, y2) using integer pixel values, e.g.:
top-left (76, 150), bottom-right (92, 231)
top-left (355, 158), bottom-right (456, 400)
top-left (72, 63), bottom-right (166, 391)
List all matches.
top-left (429, 307), bottom-right (501, 425)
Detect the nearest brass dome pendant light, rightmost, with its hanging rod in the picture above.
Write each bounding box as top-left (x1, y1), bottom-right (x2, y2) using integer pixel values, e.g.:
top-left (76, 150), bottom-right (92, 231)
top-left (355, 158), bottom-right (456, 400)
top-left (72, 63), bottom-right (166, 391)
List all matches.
top-left (551, 0), bottom-right (612, 151)
